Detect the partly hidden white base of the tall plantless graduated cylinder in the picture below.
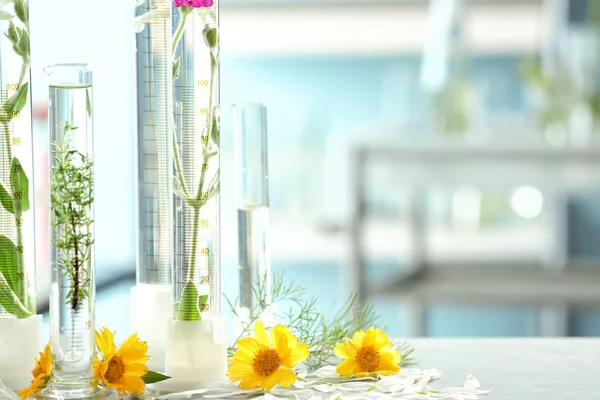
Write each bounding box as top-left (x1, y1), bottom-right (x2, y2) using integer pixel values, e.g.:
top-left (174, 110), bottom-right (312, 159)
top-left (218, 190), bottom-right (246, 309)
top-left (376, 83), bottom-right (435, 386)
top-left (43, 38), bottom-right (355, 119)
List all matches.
top-left (131, 284), bottom-right (173, 372)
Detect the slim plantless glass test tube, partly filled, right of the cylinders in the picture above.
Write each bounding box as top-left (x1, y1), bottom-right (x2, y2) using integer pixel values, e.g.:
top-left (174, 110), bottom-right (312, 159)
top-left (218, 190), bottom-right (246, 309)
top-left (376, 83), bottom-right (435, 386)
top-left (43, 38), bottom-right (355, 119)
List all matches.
top-left (232, 103), bottom-right (274, 325)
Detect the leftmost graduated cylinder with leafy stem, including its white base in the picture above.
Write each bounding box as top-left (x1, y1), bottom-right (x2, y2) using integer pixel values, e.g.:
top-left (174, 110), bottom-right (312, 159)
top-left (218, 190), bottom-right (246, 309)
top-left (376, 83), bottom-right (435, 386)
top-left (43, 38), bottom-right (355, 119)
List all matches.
top-left (0, 0), bottom-right (42, 389)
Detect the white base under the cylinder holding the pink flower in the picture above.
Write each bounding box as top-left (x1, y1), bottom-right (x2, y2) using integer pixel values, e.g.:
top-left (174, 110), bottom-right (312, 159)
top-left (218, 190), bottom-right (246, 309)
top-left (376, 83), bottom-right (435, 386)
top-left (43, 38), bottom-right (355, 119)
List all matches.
top-left (157, 315), bottom-right (227, 392)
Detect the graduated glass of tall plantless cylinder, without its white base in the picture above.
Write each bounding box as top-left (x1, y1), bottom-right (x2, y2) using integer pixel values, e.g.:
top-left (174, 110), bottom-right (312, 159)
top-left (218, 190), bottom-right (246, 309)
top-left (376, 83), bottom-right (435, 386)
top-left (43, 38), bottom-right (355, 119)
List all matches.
top-left (137, 0), bottom-right (173, 284)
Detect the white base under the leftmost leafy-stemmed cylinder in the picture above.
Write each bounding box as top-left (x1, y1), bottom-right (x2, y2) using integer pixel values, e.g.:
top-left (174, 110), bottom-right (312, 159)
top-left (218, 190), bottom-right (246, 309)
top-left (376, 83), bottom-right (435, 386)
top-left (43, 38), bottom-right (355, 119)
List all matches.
top-left (0, 315), bottom-right (44, 391)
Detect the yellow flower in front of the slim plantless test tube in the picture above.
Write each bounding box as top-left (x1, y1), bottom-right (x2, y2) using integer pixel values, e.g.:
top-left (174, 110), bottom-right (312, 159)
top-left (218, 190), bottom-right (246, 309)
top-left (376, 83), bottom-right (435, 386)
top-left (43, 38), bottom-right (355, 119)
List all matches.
top-left (227, 321), bottom-right (310, 391)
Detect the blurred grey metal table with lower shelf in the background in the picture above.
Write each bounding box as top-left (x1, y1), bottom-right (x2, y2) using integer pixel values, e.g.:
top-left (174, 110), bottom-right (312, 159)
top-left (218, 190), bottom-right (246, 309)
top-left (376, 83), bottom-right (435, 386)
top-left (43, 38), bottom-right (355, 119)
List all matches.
top-left (349, 137), bottom-right (600, 336)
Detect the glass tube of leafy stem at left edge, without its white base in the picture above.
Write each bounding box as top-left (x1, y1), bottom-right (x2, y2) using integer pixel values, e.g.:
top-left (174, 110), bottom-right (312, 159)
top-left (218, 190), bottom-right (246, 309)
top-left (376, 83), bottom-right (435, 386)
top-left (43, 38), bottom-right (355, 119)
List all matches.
top-left (0, 0), bottom-right (36, 320)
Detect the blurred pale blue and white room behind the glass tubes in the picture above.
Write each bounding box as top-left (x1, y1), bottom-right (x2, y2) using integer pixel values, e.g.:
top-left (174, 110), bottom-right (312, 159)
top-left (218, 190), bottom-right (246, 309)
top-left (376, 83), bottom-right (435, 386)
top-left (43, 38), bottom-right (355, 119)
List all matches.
top-left (31, 0), bottom-right (600, 337)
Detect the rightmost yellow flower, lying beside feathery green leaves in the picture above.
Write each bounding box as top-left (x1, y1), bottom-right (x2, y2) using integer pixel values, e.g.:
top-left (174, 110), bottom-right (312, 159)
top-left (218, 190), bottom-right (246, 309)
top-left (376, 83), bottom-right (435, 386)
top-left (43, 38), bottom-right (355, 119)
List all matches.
top-left (334, 328), bottom-right (401, 378)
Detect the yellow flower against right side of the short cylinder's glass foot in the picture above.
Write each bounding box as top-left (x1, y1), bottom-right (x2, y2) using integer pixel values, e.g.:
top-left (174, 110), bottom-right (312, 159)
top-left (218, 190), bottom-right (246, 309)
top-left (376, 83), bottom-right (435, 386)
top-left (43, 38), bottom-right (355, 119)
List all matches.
top-left (92, 328), bottom-right (150, 393)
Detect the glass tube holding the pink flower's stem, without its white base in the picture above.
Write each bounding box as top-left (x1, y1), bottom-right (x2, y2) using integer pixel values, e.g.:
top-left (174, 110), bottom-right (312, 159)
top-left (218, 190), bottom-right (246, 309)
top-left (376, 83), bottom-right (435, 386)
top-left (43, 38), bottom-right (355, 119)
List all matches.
top-left (173, 2), bottom-right (221, 321)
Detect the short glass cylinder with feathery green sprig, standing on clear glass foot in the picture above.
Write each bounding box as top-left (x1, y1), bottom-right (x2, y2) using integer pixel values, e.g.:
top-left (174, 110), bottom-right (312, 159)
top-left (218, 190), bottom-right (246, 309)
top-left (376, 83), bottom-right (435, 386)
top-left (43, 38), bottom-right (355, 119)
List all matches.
top-left (36, 64), bottom-right (113, 399)
